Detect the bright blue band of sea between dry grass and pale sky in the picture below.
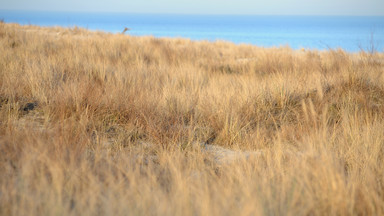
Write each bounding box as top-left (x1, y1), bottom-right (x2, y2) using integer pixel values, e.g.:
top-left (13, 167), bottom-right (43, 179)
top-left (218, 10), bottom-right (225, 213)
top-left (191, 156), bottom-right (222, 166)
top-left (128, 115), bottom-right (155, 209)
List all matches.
top-left (0, 11), bottom-right (384, 52)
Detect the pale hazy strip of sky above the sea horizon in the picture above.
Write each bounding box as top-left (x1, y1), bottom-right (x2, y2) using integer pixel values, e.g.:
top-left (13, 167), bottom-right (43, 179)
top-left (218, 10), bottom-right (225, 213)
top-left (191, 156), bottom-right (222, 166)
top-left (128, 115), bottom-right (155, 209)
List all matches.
top-left (0, 0), bottom-right (384, 16)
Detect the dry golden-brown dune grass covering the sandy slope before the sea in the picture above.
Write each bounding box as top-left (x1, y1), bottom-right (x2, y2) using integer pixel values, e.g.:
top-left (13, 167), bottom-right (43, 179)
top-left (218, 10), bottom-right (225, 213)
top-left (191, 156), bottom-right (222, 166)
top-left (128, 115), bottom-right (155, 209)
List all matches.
top-left (0, 22), bottom-right (384, 216)
